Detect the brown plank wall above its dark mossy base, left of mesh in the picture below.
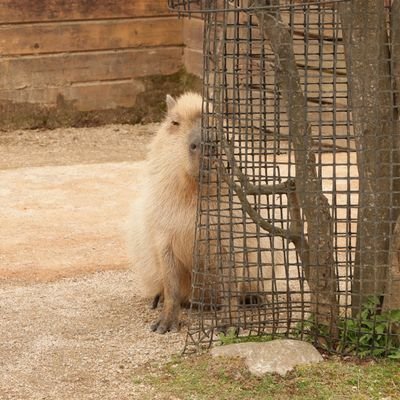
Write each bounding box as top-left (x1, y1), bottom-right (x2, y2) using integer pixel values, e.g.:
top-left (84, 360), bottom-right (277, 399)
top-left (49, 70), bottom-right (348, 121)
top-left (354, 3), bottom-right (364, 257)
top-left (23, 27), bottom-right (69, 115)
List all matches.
top-left (0, 0), bottom-right (184, 111)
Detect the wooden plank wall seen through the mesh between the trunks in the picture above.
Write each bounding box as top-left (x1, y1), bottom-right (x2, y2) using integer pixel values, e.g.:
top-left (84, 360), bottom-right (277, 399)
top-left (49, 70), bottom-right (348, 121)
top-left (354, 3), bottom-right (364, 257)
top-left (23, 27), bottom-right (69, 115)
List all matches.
top-left (193, 4), bottom-right (354, 149)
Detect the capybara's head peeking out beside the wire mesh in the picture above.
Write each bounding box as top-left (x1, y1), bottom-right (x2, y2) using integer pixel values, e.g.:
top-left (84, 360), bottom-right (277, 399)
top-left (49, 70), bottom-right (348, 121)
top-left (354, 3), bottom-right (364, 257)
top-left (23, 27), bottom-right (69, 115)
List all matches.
top-left (165, 92), bottom-right (202, 179)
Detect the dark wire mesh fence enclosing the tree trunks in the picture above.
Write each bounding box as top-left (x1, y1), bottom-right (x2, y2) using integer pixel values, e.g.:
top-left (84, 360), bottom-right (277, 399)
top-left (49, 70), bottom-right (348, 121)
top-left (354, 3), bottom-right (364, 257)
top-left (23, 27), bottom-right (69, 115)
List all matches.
top-left (169, 0), bottom-right (400, 357)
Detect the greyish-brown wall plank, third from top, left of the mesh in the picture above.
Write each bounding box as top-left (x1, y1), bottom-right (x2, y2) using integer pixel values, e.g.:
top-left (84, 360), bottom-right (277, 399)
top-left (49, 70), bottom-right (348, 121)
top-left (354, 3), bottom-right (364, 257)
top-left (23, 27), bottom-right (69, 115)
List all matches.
top-left (0, 47), bottom-right (183, 92)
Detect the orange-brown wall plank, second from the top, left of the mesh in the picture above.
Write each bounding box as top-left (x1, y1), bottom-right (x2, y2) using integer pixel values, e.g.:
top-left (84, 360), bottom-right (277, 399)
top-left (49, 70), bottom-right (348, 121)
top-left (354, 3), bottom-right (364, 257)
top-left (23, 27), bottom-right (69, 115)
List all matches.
top-left (0, 18), bottom-right (183, 56)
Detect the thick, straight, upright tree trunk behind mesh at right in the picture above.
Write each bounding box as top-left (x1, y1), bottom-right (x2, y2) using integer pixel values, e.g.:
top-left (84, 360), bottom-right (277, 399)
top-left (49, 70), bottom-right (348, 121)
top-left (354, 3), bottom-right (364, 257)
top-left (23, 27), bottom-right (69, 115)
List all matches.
top-left (339, 0), bottom-right (397, 314)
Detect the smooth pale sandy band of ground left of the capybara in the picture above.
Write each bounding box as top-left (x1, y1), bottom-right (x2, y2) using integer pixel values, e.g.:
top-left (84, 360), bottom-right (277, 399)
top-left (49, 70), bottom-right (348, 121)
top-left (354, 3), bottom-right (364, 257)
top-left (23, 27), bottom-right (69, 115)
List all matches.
top-left (0, 162), bottom-right (140, 282)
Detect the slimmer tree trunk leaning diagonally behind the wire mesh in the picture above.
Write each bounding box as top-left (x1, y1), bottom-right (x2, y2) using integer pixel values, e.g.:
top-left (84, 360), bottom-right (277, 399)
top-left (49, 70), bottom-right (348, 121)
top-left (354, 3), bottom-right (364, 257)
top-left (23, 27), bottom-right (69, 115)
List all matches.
top-left (249, 0), bottom-right (338, 337)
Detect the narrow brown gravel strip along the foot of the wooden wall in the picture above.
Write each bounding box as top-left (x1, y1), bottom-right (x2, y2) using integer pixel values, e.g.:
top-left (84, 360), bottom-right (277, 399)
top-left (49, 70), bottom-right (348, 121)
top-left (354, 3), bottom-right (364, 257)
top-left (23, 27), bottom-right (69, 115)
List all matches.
top-left (0, 123), bottom-right (158, 169)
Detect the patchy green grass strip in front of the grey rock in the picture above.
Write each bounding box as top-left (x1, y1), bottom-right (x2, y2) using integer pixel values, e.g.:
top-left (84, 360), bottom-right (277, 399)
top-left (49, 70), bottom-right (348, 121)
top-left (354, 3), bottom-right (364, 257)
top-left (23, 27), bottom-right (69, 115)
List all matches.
top-left (133, 354), bottom-right (400, 400)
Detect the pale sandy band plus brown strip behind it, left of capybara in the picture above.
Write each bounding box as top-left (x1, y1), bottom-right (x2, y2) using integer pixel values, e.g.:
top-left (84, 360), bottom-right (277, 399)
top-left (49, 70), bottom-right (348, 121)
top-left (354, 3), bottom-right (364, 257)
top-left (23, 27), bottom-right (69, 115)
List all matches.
top-left (0, 124), bottom-right (156, 282)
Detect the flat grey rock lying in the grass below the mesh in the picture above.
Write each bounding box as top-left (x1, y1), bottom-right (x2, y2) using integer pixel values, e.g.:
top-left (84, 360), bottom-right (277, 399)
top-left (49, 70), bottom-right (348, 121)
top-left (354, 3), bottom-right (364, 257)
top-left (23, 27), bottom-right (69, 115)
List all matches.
top-left (211, 339), bottom-right (323, 376)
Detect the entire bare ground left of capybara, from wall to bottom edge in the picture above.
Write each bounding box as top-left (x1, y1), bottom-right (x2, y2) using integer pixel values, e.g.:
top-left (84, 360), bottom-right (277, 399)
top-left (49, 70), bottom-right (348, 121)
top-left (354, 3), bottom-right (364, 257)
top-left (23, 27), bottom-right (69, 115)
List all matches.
top-left (0, 125), bottom-right (185, 400)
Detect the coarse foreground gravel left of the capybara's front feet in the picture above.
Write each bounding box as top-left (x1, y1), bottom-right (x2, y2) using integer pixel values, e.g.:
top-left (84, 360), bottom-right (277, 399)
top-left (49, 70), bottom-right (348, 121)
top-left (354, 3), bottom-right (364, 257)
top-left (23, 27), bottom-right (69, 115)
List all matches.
top-left (0, 271), bottom-right (185, 400)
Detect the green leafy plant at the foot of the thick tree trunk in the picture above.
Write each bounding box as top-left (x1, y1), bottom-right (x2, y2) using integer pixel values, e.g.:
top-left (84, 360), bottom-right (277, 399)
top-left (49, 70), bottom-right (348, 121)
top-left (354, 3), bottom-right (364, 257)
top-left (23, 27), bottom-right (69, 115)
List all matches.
top-left (339, 297), bottom-right (400, 359)
